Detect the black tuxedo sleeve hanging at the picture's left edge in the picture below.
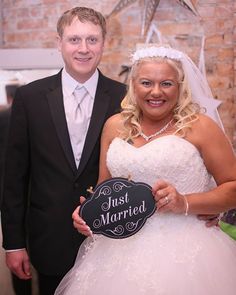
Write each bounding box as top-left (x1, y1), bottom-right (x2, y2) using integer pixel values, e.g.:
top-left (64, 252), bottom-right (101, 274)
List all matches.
top-left (1, 88), bottom-right (30, 250)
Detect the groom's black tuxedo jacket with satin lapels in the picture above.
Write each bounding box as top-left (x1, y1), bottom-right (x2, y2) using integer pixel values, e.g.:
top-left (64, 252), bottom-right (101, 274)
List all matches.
top-left (1, 72), bottom-right (126, 275)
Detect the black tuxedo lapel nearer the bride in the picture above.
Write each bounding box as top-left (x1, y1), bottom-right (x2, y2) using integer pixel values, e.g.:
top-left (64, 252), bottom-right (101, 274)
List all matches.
top-left (77, 73), bottom-right (111, 177)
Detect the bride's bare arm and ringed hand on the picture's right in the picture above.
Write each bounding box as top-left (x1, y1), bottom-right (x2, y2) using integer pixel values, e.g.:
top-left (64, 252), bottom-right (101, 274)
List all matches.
top-left (153, 115), bottom-right (236, 215)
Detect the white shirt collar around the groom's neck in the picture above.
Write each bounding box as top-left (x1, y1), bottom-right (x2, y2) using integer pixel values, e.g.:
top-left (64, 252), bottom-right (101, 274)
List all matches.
top-left (62, 68), bottom-right (99, 99)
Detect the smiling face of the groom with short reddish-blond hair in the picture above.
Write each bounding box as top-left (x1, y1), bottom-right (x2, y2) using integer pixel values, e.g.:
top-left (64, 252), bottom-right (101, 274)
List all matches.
top-left (58, 18), bottom-right (104, 83)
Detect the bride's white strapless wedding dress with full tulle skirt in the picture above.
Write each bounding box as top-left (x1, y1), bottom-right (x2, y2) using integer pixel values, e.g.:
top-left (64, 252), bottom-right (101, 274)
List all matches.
top-left (55, 135), bottom-right (236, 295)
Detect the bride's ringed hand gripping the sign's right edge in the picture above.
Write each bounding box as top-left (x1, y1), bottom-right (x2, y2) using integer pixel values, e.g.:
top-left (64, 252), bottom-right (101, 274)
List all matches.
top-left (152, 180), bottom-right (188, 214)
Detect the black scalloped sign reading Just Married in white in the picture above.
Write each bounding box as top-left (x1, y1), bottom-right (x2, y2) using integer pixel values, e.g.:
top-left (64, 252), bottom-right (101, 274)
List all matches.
top-left (80, 178), bottom-right (156, 239)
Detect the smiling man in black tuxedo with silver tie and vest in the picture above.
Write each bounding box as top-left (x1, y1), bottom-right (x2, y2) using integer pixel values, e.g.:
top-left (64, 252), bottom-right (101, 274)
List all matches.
top-left (1, 7), bottom-right (126, 295)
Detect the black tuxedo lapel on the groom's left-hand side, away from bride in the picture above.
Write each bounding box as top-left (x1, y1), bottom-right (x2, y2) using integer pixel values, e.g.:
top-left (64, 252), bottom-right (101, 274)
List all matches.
top-left (47, 75), bottom-right (77, 171)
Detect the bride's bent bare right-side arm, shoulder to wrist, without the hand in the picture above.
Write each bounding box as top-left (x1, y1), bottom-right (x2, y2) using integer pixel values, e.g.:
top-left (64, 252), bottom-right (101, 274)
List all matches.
top-left (188, 116), bottom-right (236, 214)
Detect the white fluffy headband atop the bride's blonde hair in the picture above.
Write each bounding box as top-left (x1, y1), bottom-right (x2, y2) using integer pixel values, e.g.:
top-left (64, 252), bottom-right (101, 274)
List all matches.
top-left (131, 46), bottom-right (183, 64)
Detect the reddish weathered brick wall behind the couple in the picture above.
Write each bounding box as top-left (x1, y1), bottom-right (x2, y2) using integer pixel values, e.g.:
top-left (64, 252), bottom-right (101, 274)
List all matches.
top-left (0, 0), bottom-right (236, 148)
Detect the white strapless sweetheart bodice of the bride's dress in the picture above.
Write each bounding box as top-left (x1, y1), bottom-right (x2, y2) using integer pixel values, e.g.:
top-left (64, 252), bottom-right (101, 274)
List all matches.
top-left (107, 135), bottom-right (213, 194)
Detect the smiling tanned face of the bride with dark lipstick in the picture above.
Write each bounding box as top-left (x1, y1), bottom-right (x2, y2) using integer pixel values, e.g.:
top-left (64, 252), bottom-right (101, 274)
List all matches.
top-left (133, 61), bottom-right (179, 120)
